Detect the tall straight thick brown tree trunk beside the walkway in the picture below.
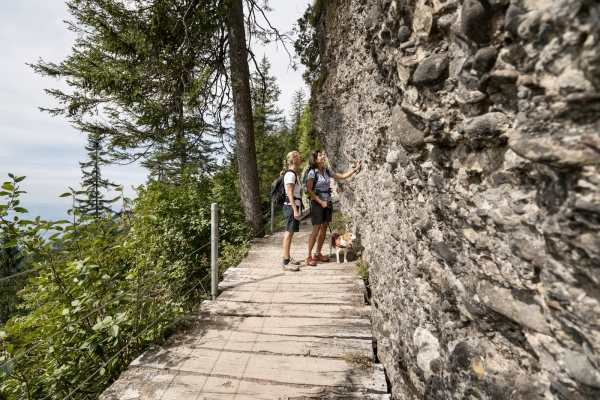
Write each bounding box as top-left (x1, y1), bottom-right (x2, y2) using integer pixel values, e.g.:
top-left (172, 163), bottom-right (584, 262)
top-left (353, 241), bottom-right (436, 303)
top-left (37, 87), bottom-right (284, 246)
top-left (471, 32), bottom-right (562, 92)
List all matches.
top-left (227, 0), bottom-right (265, 237)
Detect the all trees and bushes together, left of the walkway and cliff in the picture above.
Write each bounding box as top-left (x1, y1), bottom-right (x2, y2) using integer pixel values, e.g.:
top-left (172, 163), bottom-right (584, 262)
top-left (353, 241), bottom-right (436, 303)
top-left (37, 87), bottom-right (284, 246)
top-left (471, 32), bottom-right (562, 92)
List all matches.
top-left (0, 0), bottom-right (319, 400)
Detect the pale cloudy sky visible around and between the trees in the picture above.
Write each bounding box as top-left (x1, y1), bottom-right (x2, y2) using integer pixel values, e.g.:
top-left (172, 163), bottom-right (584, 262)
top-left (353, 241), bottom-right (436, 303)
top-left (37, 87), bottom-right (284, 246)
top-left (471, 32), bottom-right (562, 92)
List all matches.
top-left (0, 0), bottom-right (310, 220)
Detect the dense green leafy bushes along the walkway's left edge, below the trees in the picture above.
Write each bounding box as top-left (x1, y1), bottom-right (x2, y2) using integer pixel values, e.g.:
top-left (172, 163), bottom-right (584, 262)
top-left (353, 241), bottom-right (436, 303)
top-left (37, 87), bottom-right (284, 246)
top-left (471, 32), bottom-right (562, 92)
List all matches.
top-left (0, 173), bottom-right (248, 399)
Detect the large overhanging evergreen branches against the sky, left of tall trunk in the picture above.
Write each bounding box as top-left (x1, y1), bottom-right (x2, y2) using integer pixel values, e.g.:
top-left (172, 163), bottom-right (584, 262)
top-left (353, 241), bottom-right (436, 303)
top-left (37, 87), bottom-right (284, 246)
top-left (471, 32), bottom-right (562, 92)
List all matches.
top-left (33, 0), bottom-right (223, 177)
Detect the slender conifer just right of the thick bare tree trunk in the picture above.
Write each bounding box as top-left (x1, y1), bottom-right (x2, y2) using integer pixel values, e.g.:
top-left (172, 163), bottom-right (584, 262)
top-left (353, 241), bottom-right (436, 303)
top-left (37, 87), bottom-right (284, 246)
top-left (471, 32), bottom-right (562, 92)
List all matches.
top-left (250, 56), bottom-right (284, 198)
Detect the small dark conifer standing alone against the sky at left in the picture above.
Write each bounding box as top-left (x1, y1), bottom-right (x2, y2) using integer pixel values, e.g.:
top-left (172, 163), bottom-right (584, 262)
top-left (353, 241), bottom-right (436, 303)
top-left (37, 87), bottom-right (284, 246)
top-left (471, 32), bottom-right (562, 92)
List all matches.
top-left (77, 134), bottom-right (118, 218)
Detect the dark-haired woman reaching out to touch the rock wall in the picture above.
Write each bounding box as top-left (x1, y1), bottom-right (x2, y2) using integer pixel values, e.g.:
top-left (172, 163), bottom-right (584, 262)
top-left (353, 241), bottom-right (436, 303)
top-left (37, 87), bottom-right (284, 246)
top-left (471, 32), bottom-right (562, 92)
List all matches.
top-left (306, 150), bottom-right (362, 267)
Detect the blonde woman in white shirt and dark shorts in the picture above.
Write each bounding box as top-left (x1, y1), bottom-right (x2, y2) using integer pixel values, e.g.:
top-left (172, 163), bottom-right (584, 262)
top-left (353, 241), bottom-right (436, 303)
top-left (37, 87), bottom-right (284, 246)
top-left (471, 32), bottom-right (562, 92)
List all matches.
top-left (280, 151), bottom-right (302, 271)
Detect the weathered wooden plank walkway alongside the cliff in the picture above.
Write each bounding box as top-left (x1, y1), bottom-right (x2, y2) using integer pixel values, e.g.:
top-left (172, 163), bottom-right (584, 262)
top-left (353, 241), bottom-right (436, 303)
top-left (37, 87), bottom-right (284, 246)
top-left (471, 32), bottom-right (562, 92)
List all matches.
top-left (100, 227), bottom-right (390, 400)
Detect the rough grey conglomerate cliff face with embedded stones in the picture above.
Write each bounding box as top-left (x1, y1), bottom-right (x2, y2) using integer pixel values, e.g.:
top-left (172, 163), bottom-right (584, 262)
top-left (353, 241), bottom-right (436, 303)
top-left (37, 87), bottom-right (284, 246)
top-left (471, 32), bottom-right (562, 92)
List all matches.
top-left (313, 0), bottom-right (600, 400)
